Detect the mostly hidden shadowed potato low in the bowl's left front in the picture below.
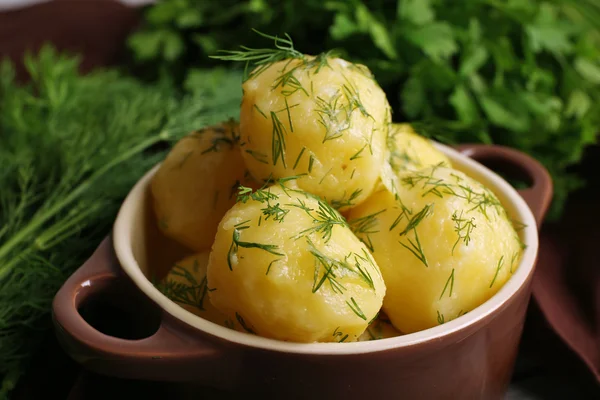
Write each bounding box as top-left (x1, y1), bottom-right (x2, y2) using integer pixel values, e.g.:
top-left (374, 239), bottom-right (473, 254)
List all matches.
top-left (158, 255), bottom-right (241, 330)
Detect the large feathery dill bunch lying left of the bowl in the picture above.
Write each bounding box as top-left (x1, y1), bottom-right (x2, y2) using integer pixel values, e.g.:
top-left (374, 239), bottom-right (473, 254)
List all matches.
top-left (0, 47), bottom-right (241, 397)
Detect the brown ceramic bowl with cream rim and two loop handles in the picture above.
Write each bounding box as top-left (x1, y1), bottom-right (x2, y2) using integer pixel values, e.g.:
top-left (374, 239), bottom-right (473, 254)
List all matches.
top-left (53, 145), bottom-right (552, 400)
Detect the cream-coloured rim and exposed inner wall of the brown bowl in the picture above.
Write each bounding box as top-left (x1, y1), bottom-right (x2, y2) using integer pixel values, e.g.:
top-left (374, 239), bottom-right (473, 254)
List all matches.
top-left (113, 143), bottom-right (538, 354)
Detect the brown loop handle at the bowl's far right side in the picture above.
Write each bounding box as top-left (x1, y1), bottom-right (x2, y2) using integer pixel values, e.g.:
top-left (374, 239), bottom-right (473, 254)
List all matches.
top-left (456, 144), bottom-right (553, 228)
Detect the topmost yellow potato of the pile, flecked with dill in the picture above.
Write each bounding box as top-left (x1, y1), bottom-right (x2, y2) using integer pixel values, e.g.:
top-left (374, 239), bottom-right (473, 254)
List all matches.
top-left (240, 55), bottom-right (391, 209)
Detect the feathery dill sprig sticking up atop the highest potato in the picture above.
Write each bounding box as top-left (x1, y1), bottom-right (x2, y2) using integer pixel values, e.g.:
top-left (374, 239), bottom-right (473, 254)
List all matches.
top-left (210, 29), bottom-right (305, 80)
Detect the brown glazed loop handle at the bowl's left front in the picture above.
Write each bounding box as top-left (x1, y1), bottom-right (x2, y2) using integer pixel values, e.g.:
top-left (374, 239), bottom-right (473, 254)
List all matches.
top-left (52, 237), bottom-right (232, 383)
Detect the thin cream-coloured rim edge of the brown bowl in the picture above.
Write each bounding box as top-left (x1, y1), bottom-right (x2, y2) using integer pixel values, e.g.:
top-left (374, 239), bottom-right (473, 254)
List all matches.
top-left (112, 143), bottom-right (539, 355)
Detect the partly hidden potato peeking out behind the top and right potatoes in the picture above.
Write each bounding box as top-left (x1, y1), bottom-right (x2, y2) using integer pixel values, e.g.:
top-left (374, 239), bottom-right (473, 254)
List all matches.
top-left (388, 124), bottom-right (452, 173)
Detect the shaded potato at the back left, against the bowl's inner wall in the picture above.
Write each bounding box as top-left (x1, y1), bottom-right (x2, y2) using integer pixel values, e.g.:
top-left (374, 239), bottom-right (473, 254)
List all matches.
top-left (151, 121), bottom-right (256, 251)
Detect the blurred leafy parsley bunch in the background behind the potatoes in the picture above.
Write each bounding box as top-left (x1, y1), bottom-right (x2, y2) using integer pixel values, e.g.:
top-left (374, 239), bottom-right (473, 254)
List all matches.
top-left (129, 0), bottom-right (600, 216)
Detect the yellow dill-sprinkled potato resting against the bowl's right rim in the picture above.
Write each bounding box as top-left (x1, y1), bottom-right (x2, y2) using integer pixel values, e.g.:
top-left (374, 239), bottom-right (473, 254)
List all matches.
top-left (349, 166), bottom-right (522, 333)
